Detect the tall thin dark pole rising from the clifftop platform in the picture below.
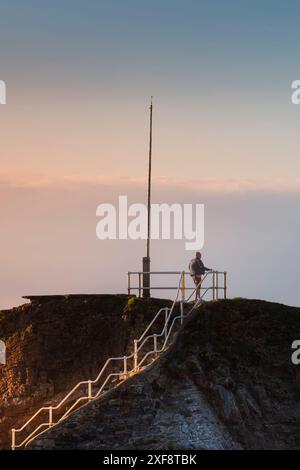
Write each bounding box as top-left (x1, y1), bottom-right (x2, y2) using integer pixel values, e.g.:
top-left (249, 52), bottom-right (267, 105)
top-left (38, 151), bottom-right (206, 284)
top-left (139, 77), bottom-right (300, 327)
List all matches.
top-left (143, 96), bottom-right (153, 297)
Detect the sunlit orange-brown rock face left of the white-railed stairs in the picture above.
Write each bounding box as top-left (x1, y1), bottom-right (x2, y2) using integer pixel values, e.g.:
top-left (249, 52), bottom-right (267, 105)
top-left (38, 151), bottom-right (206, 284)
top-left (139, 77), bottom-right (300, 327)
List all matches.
top-left (0, 295), bottom-right (170, 449)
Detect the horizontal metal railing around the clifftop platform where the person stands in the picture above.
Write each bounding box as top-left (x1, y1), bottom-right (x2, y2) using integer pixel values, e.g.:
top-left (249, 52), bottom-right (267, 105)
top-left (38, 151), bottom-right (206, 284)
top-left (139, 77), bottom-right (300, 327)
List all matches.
top-left (127, 270), bottom-right (227, 300)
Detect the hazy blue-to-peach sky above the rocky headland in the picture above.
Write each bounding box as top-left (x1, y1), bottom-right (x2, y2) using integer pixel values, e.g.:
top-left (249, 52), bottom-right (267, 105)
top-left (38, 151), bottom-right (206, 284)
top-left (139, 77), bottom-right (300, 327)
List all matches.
top-left (0, 0), bottom-right (300, 308)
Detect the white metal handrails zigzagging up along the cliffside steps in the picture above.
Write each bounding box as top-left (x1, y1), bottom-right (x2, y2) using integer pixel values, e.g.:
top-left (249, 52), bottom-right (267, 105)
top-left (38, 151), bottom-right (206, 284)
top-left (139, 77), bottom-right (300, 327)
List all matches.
top-left (12, 271), bottom-right (226, 450)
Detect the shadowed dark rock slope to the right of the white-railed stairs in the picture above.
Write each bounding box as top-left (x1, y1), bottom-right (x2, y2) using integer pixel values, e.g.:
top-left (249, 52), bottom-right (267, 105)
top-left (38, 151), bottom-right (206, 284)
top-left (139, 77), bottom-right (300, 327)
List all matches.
top-left (31, 299), bottom-right (300, 450)
